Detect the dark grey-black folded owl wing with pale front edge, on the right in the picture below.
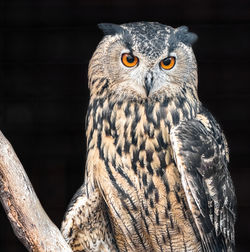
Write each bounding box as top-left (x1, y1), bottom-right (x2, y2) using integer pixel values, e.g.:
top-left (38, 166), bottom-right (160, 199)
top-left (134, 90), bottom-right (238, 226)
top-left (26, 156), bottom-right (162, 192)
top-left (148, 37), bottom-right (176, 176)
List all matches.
top-left (170, 111), bottom-right (236, 252)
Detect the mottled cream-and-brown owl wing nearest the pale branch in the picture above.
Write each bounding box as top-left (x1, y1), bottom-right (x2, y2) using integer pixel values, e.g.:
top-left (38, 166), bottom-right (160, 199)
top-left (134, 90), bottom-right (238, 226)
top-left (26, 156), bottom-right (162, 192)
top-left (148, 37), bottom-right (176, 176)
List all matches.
top-left (61, 184), bottom-right (117, 252)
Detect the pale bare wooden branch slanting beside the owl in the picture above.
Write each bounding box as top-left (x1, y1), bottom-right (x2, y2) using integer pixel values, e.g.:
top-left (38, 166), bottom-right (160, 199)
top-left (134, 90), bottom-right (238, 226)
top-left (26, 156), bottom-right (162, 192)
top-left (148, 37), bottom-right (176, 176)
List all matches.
top-left (0, 131), bottom-right (72, 252)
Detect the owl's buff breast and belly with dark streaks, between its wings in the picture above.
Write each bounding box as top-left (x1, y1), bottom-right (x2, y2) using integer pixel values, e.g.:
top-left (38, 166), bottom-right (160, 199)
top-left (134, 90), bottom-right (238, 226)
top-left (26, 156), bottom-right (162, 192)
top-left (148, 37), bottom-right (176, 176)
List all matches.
top-left (88, 104), bottom-right (202, 251)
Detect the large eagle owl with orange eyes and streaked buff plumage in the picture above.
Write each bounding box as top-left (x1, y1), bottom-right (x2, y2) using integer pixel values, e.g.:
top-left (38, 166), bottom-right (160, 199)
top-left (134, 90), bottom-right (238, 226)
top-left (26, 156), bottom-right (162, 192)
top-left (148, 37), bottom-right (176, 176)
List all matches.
top-left (61, 22), bottom-right (236, 252)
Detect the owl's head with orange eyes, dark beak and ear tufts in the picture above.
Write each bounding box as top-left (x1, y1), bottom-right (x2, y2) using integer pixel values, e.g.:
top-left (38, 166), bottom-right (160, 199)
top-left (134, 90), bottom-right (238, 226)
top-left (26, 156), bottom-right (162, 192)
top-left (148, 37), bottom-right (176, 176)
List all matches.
top-left (89, 22), bottom-right (197, 100)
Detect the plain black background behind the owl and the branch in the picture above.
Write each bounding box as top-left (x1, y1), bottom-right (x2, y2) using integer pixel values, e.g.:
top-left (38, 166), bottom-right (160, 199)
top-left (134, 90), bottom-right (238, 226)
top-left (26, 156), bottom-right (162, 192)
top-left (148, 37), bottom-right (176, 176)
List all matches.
top-left (0, 0), bottom-right (250, 252)
